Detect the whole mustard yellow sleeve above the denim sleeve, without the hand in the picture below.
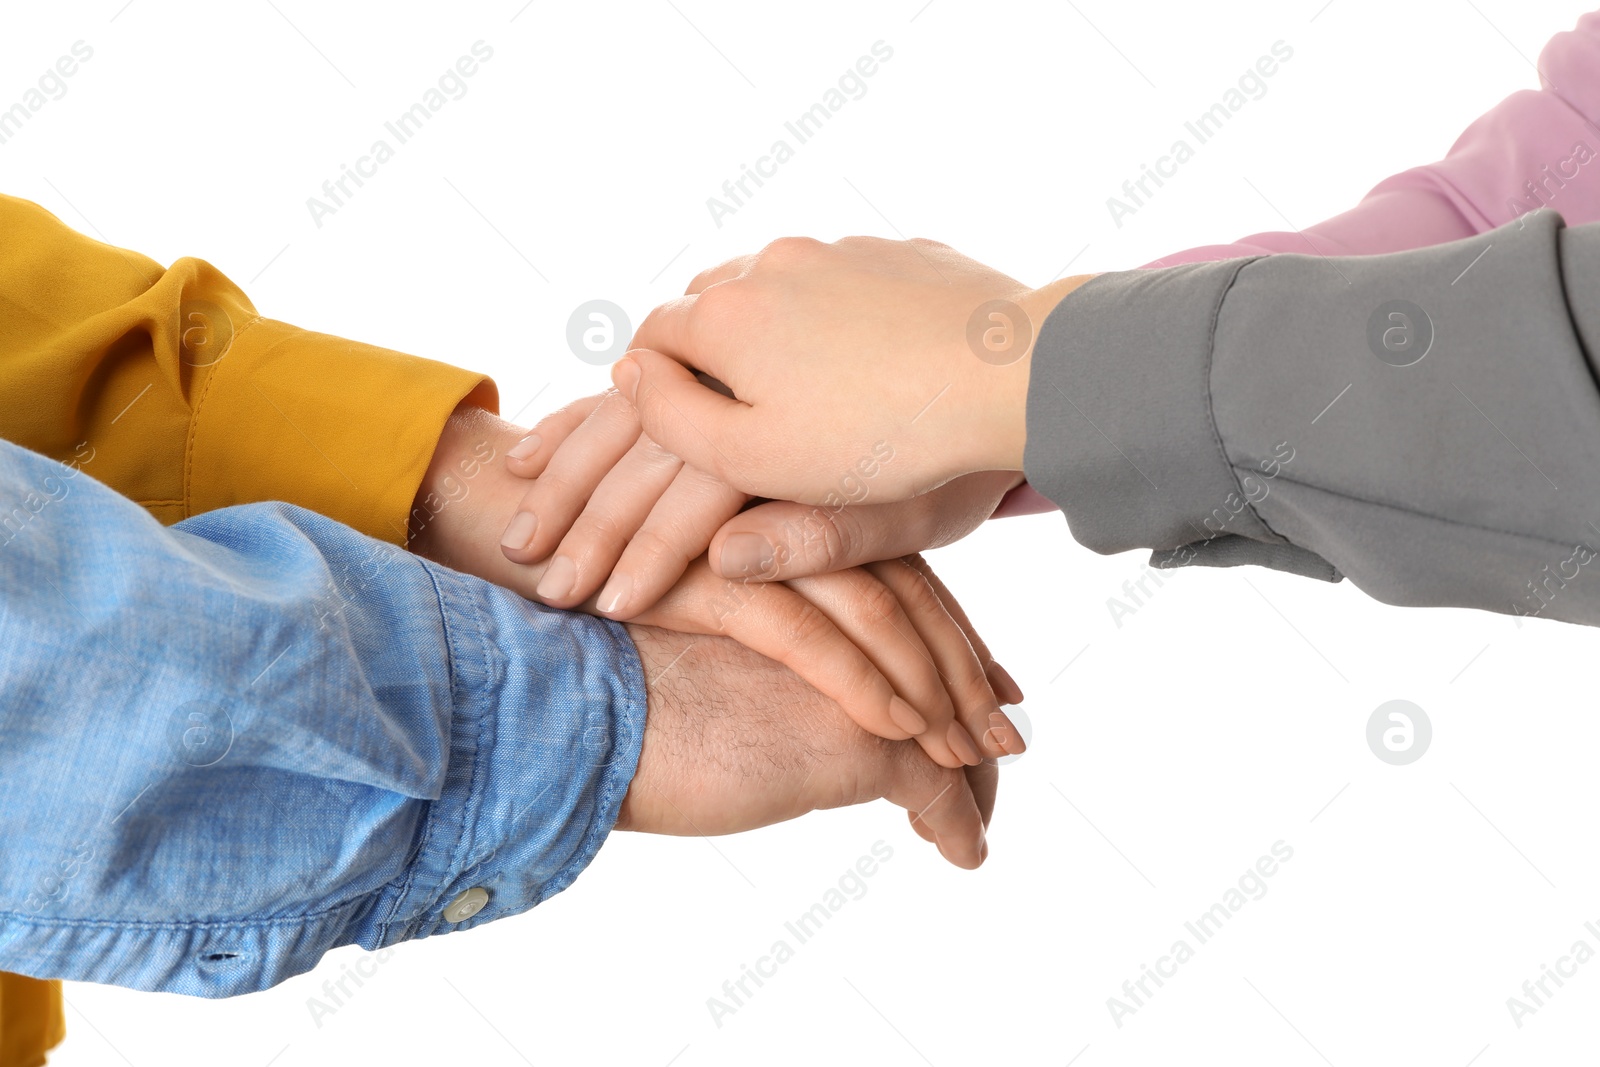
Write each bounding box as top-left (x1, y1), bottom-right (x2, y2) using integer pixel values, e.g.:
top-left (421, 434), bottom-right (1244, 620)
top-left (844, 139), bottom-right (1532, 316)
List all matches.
top-left (0, 195), bottom-right (499, 544)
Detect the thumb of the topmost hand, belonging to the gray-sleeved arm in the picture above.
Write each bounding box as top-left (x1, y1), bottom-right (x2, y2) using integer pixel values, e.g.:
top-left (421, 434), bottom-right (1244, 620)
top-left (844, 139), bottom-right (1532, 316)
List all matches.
top-left (611, 349), bottom-right (752, 493)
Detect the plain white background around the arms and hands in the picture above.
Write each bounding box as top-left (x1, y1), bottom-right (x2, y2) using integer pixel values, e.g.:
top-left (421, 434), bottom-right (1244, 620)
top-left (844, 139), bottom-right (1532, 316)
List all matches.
top-left (0, 0), bottom-right (1600, 1067)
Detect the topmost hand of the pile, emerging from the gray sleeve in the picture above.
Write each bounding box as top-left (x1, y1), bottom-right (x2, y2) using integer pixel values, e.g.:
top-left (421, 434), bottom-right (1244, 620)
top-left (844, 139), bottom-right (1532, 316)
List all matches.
top-left (611, 237), bottom-right (1082, 504)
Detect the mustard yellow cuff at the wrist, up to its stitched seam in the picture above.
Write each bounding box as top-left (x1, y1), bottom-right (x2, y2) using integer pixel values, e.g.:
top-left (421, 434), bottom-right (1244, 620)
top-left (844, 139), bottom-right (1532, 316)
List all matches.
top-left (184, 318), bottom-right (499, 544)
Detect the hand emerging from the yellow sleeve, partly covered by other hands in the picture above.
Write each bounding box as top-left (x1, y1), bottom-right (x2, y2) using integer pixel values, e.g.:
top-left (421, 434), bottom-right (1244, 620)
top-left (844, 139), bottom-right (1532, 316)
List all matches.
top-left (411, 402), bottom-right (1022, 766)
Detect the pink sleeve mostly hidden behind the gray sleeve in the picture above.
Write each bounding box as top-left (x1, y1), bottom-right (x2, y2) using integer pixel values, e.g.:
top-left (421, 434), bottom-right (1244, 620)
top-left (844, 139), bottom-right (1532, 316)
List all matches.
top-left (994, 11), bottom-right (1600, 518)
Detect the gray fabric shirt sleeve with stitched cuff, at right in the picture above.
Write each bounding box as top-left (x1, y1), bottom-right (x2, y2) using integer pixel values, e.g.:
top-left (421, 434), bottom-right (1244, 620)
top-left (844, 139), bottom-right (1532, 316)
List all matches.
top-left (1024, 210), bottom-right (1600, 624)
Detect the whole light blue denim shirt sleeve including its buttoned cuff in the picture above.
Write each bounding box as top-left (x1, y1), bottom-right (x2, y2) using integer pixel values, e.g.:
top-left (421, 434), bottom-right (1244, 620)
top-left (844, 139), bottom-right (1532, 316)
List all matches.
top-left (0, 442), bottom-right (645, 997)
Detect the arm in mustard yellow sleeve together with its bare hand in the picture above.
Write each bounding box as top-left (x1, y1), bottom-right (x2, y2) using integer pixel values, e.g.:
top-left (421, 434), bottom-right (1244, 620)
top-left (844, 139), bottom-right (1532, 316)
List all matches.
top-left (0, 197), bottom-right (998, 765)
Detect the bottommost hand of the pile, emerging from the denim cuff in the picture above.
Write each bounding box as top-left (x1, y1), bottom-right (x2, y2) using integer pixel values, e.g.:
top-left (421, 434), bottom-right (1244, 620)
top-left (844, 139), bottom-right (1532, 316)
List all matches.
top-left (616, 625), bottom-right (998, 869)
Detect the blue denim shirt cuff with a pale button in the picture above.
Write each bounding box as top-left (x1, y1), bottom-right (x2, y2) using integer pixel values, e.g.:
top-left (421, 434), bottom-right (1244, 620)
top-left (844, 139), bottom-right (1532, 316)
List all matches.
top-left (366, 565), bottom-right (646, 949)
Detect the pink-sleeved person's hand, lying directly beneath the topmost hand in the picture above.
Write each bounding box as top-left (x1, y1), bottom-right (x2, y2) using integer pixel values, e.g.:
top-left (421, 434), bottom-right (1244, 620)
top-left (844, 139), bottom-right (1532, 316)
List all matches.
top-left (501, 390), bottom-right (1022, 704)
